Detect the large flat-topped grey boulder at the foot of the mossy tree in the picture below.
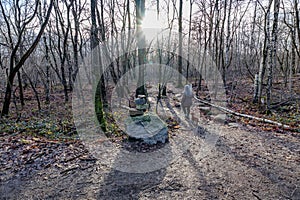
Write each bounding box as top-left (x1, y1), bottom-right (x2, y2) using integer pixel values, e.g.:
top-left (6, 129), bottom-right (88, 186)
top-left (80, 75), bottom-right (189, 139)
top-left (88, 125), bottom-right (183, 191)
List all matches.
top-left (126, 114), bottom-right (168, 144)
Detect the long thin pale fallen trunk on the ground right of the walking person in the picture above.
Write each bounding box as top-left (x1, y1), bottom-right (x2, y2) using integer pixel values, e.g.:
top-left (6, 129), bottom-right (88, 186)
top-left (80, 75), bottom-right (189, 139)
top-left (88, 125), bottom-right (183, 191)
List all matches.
top-left (194, 97), bottom-right (290, 128)
